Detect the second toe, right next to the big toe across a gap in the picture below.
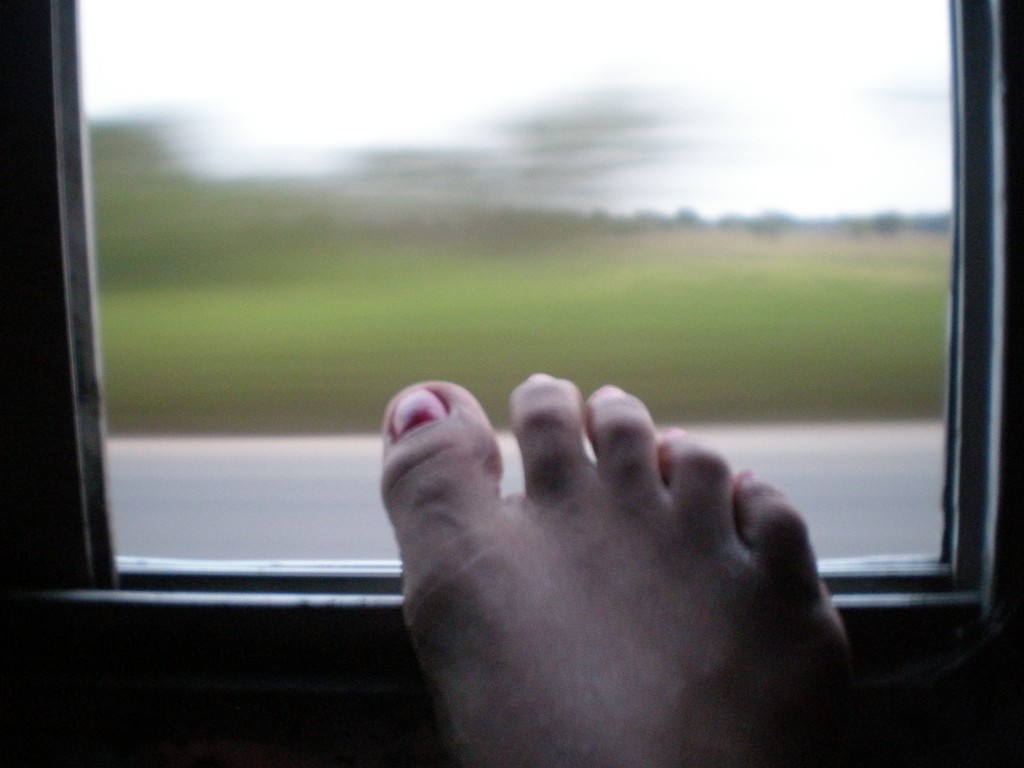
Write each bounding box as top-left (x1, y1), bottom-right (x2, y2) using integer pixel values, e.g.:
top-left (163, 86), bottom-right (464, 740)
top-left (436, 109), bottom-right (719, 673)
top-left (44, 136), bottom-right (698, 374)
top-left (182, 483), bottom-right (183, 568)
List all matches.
top-left (511, 374), bottom-right (589, 503)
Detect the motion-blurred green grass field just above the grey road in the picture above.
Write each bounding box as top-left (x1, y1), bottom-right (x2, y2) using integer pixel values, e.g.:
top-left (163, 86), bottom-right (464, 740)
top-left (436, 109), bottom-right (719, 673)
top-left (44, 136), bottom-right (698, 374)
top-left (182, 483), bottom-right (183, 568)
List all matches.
top-left (101, 224), bottom-right (947, 432)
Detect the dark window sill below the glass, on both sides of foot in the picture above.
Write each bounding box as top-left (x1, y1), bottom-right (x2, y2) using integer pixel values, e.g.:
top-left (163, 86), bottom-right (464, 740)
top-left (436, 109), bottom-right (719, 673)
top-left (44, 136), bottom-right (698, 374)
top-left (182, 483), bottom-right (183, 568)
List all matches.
top-left (0, 558), bottom-right (983, 696)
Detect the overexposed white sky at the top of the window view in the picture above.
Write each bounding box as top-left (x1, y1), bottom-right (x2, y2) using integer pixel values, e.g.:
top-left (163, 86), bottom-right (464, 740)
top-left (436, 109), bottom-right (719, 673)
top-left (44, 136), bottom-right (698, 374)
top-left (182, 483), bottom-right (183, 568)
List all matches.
top-left (80, 0), bottom-right (951, 216)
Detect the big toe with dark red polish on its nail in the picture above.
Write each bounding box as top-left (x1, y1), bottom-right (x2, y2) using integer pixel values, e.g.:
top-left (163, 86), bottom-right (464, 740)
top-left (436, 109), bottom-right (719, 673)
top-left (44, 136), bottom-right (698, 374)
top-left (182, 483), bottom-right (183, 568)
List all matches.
top-left (381, 382), bottom-right (502, 574)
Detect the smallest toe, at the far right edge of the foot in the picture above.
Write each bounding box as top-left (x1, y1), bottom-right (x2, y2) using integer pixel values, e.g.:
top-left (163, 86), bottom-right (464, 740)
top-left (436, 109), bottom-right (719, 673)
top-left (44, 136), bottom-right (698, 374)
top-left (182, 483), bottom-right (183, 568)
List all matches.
top-left (733, 471), bottom-right (821, 600)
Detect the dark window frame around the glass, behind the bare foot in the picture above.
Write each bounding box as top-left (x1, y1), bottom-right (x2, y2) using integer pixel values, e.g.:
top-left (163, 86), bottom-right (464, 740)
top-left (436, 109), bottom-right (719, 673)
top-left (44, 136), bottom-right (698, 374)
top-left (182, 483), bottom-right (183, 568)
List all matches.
top-left (0, 0), bottom-right (1020, 695)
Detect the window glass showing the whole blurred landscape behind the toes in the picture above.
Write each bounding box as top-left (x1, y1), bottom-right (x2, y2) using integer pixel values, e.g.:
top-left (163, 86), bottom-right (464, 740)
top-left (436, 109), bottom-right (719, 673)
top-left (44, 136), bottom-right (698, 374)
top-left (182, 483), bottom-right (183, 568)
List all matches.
top-left (81, 0), bottom-right (951, 559)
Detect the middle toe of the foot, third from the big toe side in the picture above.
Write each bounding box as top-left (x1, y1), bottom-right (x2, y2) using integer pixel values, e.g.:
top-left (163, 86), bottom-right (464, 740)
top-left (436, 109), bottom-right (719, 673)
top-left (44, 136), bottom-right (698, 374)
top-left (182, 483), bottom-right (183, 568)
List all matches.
top-left (587, 386), bottom-right (664, 508)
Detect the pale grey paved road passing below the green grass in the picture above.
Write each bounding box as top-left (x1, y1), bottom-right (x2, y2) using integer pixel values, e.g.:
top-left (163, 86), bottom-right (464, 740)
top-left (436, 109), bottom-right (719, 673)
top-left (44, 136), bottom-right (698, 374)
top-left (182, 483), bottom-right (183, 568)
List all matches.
top-left (108, 423), bottom-right (943, 559)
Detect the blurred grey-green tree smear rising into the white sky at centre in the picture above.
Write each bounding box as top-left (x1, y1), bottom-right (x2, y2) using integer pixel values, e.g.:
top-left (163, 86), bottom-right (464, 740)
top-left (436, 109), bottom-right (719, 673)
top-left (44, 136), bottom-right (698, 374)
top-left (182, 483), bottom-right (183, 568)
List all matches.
top-left (335, 90), bottom-right (677, 211)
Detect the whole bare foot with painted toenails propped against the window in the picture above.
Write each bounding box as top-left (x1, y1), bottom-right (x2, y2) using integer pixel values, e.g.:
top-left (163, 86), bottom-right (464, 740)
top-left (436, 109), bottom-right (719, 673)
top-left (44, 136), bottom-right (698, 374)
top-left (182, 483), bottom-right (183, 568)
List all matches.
top-left (383, 375), bottom-right (849, 768)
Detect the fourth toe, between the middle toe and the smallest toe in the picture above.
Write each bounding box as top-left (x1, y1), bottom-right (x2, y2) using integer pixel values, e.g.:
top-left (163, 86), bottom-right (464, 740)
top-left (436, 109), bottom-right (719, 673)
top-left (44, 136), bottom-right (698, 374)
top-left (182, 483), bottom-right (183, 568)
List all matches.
top-left (657, 429), bottom-right (736, 550)
